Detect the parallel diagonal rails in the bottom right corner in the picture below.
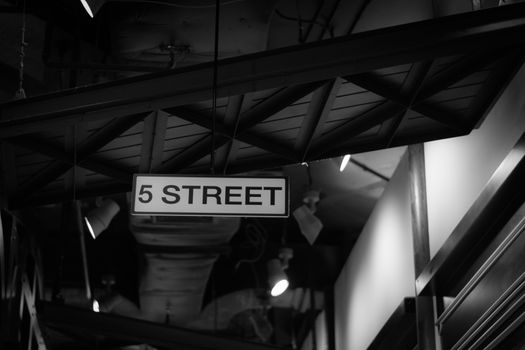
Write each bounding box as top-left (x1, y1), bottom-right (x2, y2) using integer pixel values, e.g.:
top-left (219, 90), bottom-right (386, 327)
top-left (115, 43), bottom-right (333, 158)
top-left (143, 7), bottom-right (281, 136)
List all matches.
top-left (436, 204), bottom-right (525, 350)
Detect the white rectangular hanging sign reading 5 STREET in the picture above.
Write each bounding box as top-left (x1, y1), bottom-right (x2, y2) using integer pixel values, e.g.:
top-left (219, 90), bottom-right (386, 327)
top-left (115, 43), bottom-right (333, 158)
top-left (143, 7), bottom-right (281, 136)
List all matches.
top-left (131, 174), bottom-right (289, 217)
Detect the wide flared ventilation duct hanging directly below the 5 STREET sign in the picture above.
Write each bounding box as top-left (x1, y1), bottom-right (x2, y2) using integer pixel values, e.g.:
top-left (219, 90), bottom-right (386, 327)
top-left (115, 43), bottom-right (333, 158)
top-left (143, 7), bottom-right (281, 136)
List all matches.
top-left (130, 216), bottom-right (240, 326)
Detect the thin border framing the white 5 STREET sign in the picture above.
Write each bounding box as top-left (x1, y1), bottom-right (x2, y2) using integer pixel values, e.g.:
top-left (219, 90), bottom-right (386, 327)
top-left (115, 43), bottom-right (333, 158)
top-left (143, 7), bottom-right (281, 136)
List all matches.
top-left (130, 174), bottom-right (290, 218)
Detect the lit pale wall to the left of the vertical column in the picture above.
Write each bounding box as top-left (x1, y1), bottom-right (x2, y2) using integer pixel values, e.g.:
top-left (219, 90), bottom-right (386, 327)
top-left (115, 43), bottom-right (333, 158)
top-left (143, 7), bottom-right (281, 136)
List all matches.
top-left (334, 154), bottom-right (415, 350)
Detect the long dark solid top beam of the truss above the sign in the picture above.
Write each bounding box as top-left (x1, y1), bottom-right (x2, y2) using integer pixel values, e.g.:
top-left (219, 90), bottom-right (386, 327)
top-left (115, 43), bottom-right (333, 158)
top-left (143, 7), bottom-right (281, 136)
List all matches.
top-left (0, 3), bottom-right (525, 137)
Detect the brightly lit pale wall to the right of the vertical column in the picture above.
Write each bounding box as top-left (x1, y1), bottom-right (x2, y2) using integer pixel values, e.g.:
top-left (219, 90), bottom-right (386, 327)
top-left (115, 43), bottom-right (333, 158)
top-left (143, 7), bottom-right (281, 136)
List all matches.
top-left (425, 67), bottom-right (525, 256)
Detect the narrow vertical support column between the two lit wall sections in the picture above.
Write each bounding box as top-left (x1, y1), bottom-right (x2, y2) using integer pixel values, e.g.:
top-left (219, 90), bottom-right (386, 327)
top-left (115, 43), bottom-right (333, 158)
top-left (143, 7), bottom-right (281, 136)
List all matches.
top-left (408, 144), bottom-right (438, 350)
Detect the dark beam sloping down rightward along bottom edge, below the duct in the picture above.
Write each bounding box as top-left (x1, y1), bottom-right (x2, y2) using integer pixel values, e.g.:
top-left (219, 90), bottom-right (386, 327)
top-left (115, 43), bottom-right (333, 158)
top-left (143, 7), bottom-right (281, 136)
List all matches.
top-left (37, 302), bottom-right (281, 350)
